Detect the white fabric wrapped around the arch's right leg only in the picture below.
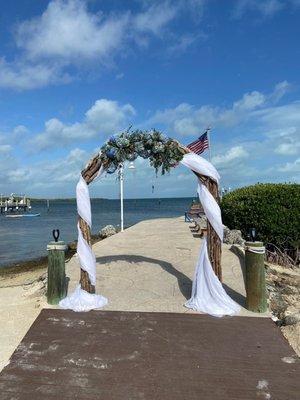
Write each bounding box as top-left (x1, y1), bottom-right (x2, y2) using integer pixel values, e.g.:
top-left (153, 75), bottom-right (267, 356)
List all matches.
top-left (181, 153), bottom-right (240, 317)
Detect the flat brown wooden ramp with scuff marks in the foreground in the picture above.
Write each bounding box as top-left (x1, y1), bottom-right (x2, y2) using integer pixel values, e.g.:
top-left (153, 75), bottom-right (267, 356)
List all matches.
top-left (0, 310), bottom-right (300, 400)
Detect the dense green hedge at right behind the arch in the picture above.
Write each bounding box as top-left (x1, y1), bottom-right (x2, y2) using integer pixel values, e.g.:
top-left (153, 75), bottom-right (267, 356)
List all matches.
top-left (221, 183), bottom-right (300, 248)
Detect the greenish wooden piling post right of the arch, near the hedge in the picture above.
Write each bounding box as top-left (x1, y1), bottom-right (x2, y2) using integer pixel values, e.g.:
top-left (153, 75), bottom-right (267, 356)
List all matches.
top-left (245, 242), bottom-right (267, 313)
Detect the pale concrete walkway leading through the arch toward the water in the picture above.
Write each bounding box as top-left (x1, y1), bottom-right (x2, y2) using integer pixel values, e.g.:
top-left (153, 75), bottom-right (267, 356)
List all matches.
top-left (67, 217), bottom-right (267, 316)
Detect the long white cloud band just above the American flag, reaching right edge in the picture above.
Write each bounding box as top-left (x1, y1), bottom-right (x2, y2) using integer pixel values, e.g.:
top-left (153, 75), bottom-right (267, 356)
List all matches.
top-left (148, 81), bottom-right (294, 136)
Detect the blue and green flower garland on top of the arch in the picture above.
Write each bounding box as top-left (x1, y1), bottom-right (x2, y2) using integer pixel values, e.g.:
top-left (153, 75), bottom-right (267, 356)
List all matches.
top-left (100, 129), bottom-right (186, 175)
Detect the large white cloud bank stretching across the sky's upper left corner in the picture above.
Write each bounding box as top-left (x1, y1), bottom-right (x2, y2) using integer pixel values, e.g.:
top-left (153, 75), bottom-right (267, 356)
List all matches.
top-left (0, 0), bottom-right (198, 90)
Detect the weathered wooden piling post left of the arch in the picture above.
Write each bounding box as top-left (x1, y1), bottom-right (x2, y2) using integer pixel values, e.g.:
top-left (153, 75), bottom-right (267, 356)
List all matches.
top-left (47, 241), bottom-right (67, 304)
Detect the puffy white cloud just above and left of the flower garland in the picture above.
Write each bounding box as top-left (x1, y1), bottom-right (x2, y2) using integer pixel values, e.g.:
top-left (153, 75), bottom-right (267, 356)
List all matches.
top-left (30, 99), bottom-right (135, 151)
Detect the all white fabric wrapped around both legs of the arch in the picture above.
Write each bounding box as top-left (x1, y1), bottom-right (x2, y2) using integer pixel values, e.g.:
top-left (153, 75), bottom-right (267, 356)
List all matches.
top-left (59, 153), bottom-right (240, 317)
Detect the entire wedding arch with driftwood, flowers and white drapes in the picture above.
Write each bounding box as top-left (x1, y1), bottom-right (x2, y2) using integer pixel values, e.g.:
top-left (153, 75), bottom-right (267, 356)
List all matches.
top-left (60, 129), bottom-right (239, 316)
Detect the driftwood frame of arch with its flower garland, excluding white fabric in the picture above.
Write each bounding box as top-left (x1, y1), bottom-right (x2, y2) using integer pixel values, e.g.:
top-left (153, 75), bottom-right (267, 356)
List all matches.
top-left (78, 131), bottom-right (222, 293)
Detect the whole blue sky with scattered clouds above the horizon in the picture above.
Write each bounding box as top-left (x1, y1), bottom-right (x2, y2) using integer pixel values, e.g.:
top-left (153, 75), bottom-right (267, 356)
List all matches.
top-left (0, 0), bottom-right (300, 198)
